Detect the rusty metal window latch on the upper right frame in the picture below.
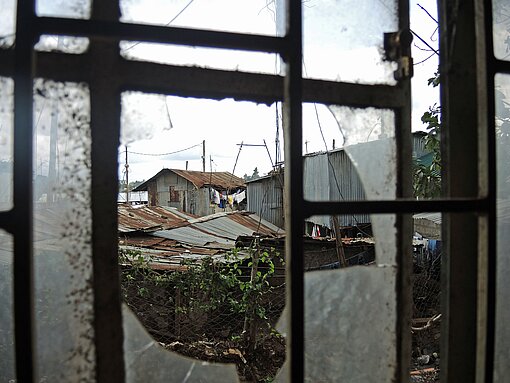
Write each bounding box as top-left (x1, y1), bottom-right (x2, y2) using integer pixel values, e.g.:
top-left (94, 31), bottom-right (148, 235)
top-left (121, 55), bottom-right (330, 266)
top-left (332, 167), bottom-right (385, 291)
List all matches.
top-left (384, 29), bottom-right (413, 81)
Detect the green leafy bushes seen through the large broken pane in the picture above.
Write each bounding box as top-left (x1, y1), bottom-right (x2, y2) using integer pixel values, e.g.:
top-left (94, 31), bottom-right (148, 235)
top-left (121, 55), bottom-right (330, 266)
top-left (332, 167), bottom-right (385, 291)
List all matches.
top-left (119, 247), bottom-right (283, 337)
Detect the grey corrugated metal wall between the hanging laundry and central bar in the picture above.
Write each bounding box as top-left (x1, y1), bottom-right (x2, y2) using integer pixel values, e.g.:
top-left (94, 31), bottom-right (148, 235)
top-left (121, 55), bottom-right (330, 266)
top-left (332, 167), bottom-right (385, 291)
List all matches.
top-left (246, 173), bottom-right (285, 228)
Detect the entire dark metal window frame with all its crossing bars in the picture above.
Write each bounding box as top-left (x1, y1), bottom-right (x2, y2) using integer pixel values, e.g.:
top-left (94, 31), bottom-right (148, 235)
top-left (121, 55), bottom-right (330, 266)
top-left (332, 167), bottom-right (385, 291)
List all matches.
top-left (0, 0), bottom-right (504, 382)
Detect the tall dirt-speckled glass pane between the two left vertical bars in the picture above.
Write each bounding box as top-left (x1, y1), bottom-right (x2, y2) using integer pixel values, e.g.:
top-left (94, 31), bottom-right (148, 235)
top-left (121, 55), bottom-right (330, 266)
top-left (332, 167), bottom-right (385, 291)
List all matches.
top-left (34, 79), bottom-right (95, 382)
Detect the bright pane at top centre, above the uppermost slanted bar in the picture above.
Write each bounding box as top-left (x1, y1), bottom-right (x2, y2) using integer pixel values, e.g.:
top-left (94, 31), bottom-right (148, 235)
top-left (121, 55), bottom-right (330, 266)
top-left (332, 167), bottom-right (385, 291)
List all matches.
top-left (120, 0), bottom-right (280, 35)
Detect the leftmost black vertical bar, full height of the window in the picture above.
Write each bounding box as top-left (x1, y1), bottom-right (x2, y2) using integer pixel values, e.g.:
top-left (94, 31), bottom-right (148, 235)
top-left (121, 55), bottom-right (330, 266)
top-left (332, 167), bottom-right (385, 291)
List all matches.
top-left (13, 0), bottom-right (35, 382)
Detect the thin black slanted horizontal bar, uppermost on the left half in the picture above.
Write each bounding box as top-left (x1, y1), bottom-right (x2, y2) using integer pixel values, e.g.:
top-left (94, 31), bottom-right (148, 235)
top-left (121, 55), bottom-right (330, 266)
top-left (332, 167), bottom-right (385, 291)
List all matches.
top-left (35, 17), bottom-right (287, 54)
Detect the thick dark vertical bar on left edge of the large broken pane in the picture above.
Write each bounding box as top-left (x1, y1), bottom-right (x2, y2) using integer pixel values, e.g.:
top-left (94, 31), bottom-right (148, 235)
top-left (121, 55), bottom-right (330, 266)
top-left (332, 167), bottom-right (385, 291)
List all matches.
top-left (88, 0), bottom-right (125, 383)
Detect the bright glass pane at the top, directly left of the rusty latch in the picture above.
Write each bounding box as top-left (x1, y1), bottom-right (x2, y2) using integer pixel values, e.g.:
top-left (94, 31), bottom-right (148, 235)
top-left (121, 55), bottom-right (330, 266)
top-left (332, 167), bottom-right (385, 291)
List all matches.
top-left (303, 0), bottom-right (398, 85)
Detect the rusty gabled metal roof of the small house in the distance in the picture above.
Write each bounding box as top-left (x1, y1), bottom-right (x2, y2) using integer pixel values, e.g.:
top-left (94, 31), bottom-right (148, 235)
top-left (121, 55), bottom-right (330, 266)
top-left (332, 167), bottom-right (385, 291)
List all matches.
top-left (133, 169), bottom-right (246, 191)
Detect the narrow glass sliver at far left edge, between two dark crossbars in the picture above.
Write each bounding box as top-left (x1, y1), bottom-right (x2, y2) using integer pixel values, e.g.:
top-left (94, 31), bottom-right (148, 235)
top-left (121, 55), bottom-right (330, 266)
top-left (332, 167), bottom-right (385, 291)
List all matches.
top-left (0, 77), bottom-right (14, 211)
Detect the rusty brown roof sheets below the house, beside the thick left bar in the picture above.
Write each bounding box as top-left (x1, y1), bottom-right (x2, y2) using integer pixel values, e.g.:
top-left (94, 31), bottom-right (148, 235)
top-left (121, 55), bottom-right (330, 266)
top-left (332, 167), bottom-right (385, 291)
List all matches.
top-left (118, 205), bottom-right (188, 233)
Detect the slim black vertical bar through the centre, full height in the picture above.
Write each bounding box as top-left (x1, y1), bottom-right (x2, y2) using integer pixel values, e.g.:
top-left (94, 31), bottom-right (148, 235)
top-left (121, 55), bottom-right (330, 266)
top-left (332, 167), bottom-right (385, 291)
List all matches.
top-left (283, 0), bottom-right (304, 382)
